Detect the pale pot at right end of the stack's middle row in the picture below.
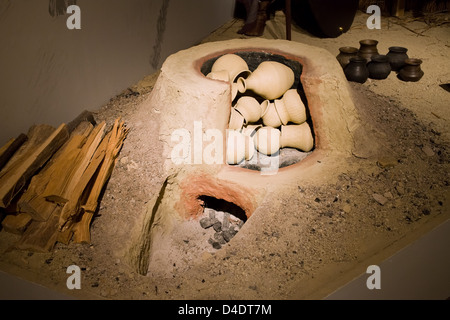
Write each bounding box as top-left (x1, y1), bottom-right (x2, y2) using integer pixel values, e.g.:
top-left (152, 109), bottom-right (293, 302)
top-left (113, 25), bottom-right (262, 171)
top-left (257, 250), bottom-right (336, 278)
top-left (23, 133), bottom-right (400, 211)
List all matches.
top-left (274, 89), bottom-right (306, 125)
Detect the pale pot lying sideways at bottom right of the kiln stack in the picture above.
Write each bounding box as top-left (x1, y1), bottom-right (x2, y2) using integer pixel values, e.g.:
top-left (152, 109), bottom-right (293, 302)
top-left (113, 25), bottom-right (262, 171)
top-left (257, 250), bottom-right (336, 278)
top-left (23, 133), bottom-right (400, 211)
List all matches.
top-left (280, 122), bottom-right (314, 152)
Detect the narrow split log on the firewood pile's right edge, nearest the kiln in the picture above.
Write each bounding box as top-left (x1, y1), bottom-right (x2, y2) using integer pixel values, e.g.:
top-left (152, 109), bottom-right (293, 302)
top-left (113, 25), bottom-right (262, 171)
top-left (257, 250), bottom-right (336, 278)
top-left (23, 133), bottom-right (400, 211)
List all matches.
top-left (73, 119), bottom-right (129, 243)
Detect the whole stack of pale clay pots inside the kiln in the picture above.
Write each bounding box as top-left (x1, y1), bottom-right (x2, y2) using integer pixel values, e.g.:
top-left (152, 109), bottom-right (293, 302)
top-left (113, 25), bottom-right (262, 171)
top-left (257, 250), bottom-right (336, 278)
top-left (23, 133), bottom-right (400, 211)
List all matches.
top-left (208, 54), bottom-right (314, 164)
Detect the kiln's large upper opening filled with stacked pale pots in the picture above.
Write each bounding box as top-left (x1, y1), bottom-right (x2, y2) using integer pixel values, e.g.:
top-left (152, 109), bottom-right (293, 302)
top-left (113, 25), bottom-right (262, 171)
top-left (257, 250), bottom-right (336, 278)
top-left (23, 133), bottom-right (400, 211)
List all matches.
top-left (200, 50), bottom-right (315, 171)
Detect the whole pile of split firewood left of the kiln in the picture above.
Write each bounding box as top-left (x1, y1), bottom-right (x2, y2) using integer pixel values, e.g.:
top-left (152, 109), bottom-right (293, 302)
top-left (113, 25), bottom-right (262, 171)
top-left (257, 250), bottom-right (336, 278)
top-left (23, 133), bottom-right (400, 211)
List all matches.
top-left (0, 111), bottom-right (129, 252)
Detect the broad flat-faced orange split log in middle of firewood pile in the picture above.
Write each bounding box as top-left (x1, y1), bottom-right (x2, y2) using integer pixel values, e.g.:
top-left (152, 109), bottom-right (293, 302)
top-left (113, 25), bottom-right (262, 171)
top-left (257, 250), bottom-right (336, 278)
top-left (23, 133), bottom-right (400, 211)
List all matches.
top-left (43, 122), bottom-right (106, 205)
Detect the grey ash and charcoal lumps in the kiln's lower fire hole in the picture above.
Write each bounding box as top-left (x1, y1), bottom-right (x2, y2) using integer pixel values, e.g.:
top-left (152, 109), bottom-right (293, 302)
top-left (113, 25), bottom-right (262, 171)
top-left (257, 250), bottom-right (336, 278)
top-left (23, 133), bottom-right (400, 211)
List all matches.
top-left (200, 208), bottom-right (245, 250)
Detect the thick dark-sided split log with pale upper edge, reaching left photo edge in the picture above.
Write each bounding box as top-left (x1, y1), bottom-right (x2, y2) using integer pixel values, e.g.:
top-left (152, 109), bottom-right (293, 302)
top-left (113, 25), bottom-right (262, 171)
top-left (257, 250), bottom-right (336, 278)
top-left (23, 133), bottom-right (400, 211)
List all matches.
top-left (0, 124), bottom-right (69, 208)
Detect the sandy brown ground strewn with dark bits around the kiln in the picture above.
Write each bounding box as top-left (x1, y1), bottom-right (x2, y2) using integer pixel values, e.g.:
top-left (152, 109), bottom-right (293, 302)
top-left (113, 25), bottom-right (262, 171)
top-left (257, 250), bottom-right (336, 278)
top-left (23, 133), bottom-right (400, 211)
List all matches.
top-left (0, 12), bottom-right (450, 299)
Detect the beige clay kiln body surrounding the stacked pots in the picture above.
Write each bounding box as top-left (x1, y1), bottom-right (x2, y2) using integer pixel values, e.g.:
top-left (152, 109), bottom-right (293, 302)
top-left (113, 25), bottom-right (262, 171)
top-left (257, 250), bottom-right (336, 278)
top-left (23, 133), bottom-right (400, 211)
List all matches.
top-left (126, 39), bottom-right (359, 274)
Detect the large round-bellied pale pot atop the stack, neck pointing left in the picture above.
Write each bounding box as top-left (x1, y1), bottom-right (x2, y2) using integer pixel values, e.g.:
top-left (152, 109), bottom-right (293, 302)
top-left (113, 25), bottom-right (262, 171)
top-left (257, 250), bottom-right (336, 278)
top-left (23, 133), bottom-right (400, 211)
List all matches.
top-left (237, 61), bottom-right (295, 100)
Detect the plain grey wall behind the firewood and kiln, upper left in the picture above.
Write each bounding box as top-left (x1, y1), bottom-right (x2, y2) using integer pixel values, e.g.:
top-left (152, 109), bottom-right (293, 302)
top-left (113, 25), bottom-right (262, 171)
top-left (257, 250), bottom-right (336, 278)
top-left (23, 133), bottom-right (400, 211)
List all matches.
top-left (0, 0), bottom-right (235, 145)
